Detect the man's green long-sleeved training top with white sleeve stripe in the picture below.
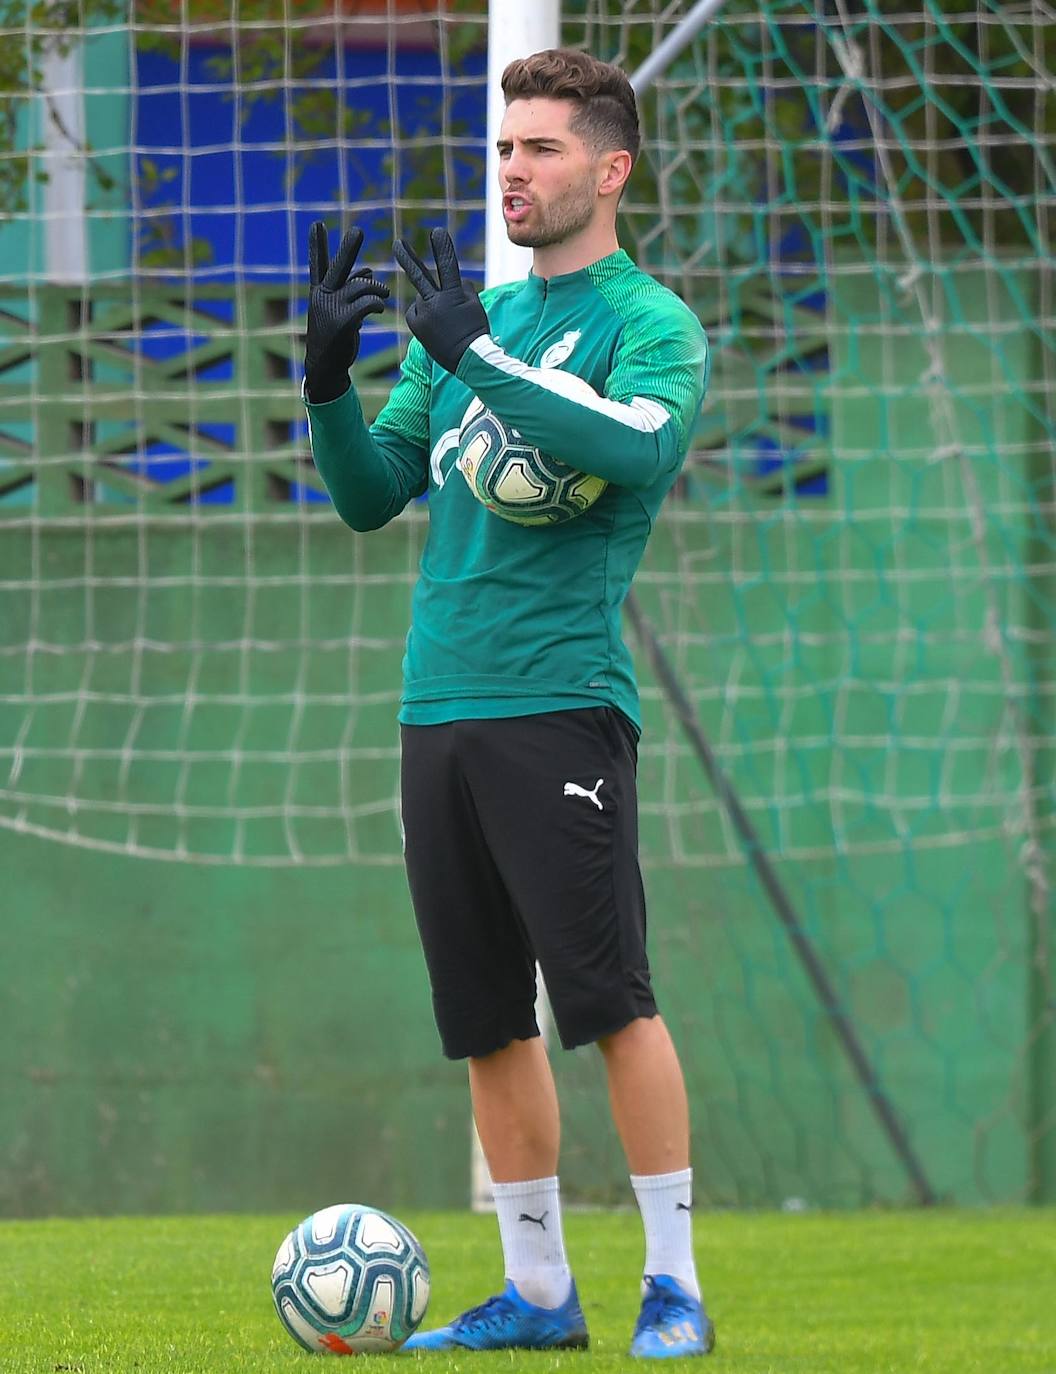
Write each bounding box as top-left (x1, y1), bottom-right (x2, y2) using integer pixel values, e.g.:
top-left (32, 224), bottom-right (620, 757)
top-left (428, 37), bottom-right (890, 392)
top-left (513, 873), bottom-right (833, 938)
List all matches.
top-left (308, 250), bottom-right (709, 728)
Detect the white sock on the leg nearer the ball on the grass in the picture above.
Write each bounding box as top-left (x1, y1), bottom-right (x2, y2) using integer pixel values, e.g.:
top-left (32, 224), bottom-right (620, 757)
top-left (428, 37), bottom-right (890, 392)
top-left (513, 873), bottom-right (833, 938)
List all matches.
top-left (492, 1178), bottom-right (573, 1307)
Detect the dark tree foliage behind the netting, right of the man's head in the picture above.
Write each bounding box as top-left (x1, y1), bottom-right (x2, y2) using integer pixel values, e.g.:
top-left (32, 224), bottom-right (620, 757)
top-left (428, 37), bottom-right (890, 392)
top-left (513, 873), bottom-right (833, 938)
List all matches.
top-left (563, 0), bottom-right (1056, 298)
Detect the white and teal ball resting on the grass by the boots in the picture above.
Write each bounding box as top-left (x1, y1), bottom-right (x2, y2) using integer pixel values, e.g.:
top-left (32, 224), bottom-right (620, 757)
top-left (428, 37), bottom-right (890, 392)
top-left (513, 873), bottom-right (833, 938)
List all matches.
top-left (272, 1202), bottom-right (428, 1355)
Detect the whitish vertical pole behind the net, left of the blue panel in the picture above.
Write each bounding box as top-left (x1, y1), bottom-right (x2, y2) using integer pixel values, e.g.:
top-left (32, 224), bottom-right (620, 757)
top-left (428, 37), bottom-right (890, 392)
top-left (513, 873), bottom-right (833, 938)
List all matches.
top-left (40, 41), bottom-right (88, 283)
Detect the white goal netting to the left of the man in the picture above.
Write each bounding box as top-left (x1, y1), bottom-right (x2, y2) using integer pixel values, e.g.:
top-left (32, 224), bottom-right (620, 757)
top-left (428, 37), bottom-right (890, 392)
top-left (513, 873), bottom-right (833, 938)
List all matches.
top-left (0, 0), bottom-right (486, 864)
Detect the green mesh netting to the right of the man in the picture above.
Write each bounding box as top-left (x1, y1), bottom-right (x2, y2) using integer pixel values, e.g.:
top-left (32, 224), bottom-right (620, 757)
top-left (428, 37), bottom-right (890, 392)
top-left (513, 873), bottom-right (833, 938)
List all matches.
top-left (554, 3), bottom-right (1056, 1205)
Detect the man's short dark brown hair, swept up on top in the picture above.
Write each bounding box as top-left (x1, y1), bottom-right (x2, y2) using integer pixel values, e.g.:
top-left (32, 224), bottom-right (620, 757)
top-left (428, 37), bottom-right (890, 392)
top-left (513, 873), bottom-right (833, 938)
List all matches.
top-left (503, 48), bottom-right (641, 162)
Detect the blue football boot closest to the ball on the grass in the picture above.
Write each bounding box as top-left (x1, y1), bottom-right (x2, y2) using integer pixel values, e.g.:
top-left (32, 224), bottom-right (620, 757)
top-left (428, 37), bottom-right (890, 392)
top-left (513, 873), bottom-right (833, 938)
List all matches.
top-left (400, 1281), bottom-right (590, 1351)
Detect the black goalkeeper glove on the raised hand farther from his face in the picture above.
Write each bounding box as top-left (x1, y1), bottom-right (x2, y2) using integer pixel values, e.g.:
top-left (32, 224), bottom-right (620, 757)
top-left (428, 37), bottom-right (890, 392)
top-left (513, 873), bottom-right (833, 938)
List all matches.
top-left (305, 220), bottom-right (389, 404)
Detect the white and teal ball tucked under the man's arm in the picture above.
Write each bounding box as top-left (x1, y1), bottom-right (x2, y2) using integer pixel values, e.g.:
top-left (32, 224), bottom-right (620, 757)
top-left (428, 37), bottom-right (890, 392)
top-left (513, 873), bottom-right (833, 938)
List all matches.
top-left (459, 371), bottom-right (608, 525)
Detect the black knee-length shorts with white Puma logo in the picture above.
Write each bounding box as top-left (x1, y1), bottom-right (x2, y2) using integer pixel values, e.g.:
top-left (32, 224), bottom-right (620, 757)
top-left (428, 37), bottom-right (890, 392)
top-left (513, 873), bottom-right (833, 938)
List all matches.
top-left (401, 706), bottom-right (656, 1059)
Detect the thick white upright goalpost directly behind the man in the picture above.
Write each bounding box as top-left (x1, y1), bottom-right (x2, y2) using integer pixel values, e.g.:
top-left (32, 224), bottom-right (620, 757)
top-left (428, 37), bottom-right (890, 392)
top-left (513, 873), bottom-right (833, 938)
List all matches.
top-left (470, 0), bottom-right (562, 1212)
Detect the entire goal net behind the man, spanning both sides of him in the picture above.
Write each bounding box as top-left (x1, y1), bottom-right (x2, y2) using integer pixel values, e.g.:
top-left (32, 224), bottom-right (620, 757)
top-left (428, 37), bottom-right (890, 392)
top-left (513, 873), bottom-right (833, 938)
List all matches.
top-left (0, 0), bottom-right (1056, 1206)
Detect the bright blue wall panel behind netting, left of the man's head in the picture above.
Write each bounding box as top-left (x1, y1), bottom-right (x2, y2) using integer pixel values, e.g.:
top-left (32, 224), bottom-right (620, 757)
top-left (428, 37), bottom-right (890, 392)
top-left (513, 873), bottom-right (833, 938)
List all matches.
top-left (135, 44), bottom-right (486, 280)
